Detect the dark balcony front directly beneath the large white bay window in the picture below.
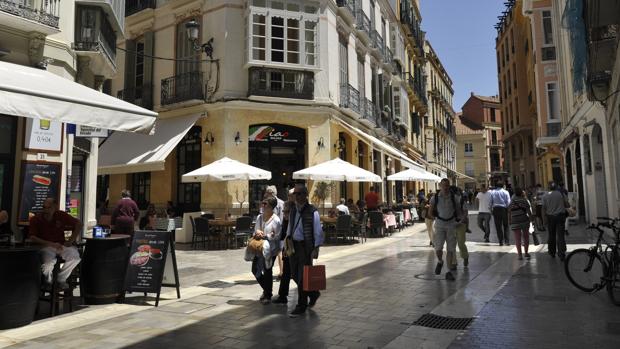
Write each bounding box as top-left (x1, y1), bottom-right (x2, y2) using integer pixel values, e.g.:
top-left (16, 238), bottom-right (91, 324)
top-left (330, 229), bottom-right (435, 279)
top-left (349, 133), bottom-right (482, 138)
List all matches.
top-left (249, 67), bottom-right (314, 99)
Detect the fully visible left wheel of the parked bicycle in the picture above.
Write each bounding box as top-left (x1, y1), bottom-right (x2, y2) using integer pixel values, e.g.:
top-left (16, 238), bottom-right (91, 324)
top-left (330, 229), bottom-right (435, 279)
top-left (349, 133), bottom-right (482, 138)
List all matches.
top-left (564, 248), bottom-right (604, 290)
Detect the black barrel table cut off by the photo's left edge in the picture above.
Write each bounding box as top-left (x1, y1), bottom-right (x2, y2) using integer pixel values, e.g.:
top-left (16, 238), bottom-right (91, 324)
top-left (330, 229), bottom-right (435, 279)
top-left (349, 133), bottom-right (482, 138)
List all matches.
top-left (0, 246), bottom-right (41, 330)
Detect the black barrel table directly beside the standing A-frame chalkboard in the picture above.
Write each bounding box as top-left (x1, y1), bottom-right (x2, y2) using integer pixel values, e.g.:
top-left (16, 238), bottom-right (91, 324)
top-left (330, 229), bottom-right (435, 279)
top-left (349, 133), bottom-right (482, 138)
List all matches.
top-left (80, 234), bottom-right (130, 304)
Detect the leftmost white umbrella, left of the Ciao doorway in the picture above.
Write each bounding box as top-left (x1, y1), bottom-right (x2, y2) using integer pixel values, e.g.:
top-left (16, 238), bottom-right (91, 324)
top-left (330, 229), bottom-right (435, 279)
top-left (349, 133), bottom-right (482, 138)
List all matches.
top-left (181, 157), bottom-right (271, 183)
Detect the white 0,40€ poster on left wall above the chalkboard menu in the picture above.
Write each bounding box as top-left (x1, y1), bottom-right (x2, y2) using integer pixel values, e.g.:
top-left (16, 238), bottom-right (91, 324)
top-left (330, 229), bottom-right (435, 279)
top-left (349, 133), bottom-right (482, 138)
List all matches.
top-left (24, 118), bottom-right (63, 152)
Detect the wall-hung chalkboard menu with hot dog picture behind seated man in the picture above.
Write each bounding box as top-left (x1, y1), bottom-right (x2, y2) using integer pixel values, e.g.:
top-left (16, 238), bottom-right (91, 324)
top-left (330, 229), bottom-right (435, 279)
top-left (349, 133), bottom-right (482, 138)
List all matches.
top-left (18, 161), bottom-right (62, 224)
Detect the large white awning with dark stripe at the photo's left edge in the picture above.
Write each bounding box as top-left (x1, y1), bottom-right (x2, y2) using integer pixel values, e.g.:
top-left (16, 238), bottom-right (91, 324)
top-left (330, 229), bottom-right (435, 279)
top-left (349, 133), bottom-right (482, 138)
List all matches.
top-left (0, 62), bottom-right (157, 134)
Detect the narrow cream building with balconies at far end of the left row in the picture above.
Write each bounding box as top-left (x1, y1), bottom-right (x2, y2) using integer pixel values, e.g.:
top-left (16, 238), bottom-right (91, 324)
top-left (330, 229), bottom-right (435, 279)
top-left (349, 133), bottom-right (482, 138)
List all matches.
top-left (424, 41), bottom-right (458, 183)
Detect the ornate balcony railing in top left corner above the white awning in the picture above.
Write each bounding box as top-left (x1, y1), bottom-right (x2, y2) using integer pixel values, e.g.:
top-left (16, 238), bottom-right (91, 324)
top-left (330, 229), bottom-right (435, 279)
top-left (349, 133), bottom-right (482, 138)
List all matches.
top-left (0, 0), bottom-right (60, 28)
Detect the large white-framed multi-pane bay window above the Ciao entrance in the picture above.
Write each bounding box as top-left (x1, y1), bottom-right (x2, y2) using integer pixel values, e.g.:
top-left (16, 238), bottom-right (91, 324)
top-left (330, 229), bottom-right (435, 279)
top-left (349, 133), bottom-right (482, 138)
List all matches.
top-left (247, 0), bottom-right (319, 66)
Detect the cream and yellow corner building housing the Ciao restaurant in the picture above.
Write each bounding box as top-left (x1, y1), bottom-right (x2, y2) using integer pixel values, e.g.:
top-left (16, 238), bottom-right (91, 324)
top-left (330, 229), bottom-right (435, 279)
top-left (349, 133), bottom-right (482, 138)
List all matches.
top-left (99, 0), bottom-right (444, 213)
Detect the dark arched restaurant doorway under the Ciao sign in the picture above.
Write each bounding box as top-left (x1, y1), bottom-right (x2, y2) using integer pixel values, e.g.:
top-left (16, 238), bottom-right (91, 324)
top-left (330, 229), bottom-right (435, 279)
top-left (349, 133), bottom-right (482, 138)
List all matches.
top-left (248, 124), bottom-right (306, 215)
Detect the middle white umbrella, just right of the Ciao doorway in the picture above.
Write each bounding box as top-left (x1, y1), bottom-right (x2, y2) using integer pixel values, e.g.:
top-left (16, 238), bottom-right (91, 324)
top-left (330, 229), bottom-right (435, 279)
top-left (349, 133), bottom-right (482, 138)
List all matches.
top-left (293, 158), bottom-right (382, 182)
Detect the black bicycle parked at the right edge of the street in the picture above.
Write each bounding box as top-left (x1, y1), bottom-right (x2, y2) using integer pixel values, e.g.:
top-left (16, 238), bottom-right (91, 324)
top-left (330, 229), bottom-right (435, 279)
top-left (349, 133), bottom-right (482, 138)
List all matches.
top-left (564, 217), bottom-right (620, 306)
